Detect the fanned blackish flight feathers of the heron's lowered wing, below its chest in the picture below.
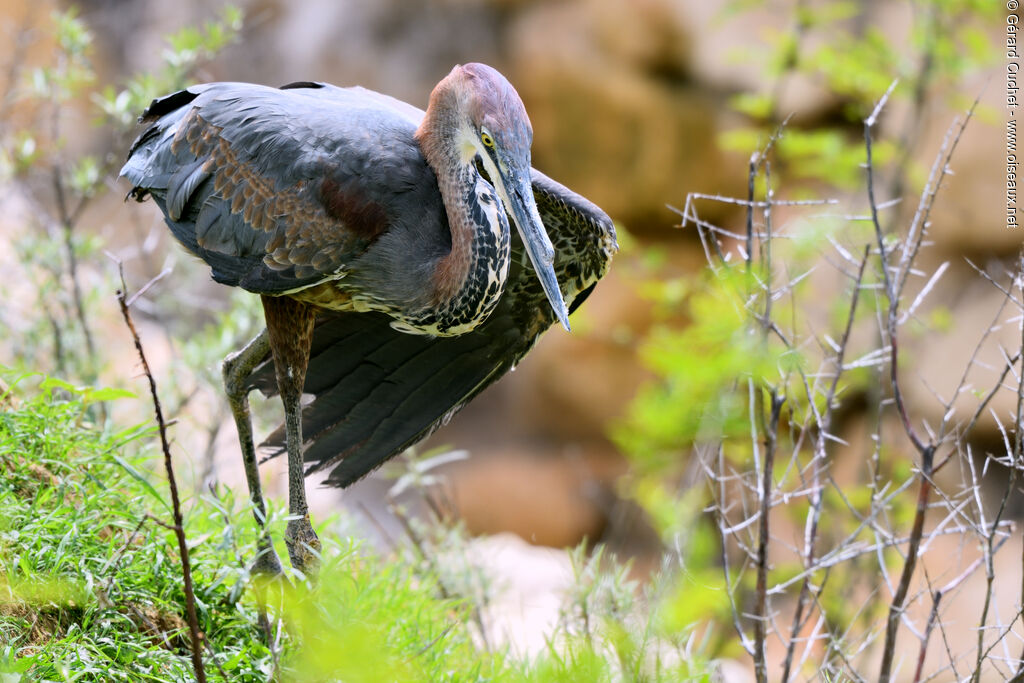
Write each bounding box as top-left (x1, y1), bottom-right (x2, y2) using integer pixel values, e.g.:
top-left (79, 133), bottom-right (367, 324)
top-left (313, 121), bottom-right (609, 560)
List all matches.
top-left (247, 311), bottom-right (524, 486)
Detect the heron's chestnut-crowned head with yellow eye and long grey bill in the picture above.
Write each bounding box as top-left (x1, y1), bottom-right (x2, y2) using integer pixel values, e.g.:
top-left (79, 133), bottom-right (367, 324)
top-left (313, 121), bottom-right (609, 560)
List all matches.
top-left (417, 63), bottom-right (569, 330)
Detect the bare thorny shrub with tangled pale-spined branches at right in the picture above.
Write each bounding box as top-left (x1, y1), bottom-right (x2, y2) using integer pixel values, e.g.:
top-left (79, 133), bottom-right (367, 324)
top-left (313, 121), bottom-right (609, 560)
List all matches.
top-left (678, 69), bottom-right (1024, 682)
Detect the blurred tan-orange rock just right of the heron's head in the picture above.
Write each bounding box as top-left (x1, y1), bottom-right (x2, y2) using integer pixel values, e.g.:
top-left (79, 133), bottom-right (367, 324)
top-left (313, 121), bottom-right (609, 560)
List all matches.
top-left (508, 1), bottom-right (745, 239)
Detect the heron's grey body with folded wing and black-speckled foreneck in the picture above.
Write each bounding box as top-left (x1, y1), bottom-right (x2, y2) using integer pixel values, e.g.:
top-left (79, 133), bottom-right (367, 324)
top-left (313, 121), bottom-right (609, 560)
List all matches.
top-left (122, 83), bottom-right (509, 336)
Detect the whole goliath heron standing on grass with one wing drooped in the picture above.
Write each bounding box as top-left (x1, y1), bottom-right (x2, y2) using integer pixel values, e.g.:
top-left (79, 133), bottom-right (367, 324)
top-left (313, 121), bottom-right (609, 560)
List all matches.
top-left (121, 63), bottom-right (616, 572)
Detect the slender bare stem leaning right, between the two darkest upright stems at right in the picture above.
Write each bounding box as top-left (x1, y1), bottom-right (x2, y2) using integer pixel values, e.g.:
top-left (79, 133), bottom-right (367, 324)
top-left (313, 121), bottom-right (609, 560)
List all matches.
top-left (782, 247), bottom-right (870, 683)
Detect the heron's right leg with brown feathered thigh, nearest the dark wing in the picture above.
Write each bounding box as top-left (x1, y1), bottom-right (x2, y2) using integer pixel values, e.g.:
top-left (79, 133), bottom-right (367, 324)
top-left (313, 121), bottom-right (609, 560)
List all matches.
top-left (263, 296), bottom-right (321, 571)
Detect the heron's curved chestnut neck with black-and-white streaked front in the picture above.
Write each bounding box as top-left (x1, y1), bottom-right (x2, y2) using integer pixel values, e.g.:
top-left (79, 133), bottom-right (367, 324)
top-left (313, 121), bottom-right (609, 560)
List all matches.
top-left (417, 115), bottom-right (510, 335)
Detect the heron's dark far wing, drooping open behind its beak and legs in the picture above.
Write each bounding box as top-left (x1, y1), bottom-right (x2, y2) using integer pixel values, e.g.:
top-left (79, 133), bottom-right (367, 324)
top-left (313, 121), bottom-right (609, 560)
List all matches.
top-left (250, 173), bottom-right (615, 486)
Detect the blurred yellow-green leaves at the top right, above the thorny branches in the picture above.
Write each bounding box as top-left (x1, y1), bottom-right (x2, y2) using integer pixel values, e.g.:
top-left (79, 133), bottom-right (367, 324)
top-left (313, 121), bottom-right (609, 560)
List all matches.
top-left (720, 0), bottom-right (998, 189)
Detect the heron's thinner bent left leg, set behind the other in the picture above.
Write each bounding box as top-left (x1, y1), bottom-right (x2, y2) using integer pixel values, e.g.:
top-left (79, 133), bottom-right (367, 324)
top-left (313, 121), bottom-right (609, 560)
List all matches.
top-left (220, 330), bottom-right (282, 574)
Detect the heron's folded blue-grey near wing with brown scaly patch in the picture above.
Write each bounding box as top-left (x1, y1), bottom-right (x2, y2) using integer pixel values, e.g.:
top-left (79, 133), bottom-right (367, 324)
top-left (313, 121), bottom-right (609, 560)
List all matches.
top-left (121, 83), bottom-right (432, 294)
